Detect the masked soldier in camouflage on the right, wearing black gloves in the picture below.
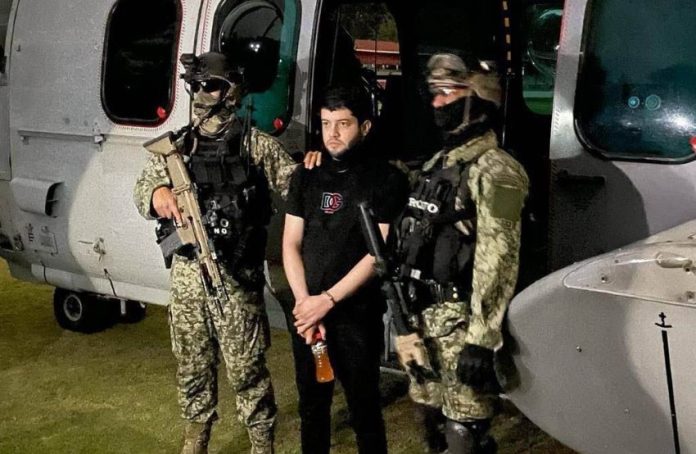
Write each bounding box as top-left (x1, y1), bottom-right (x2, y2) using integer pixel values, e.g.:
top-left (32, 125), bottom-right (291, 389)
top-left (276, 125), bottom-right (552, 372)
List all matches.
top-left (394, 53), bottom-right (528, 454)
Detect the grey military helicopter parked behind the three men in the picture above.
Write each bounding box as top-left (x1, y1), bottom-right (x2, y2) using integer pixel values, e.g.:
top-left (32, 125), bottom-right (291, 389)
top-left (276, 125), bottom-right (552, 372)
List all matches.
top-left (0, 0), bottom-right (696, 453)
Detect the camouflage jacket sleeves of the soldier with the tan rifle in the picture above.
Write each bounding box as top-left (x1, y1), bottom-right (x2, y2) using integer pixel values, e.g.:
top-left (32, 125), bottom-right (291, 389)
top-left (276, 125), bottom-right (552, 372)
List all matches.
top-left (133, 128), bottom-right (297, 219)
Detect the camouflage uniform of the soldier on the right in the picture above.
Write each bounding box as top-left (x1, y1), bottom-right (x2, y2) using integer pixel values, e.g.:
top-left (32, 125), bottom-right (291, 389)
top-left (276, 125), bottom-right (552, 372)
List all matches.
top-left (402, 131), bottom-right (528, 422)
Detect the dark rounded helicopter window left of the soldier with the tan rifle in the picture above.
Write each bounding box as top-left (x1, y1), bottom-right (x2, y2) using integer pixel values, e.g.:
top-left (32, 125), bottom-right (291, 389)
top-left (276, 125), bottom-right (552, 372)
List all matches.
top-left (102, 0), bottom-right (181, 125)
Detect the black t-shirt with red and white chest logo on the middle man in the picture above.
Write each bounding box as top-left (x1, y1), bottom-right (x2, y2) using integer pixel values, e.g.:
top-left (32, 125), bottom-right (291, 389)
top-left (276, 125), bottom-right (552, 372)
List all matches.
top-left (287, 154), bottom-right (408, 312)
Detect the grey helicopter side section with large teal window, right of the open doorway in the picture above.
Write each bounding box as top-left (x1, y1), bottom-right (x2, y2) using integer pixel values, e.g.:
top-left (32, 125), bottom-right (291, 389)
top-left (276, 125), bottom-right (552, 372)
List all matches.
top-left (549, 0), bottom-right (696, 269)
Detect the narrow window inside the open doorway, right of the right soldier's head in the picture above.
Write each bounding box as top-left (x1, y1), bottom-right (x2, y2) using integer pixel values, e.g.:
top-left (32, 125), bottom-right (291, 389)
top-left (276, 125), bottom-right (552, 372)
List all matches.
top-left (521, 4), bottom-right (563, 115)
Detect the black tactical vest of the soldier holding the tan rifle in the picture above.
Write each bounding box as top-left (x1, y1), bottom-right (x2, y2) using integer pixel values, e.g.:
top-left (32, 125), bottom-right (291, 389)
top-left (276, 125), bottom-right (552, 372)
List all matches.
top-left (188, 132), bottom-right (272, 287)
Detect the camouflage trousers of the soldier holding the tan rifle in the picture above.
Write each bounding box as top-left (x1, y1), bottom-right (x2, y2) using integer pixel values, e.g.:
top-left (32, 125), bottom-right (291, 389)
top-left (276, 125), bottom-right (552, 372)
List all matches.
top-left (169, 257), bottom-right (276, 453)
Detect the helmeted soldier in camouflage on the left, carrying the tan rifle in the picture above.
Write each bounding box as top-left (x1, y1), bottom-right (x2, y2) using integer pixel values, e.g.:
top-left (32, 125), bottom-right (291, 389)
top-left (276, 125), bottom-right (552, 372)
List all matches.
top-left (134, 52), bottom-right (295, 454)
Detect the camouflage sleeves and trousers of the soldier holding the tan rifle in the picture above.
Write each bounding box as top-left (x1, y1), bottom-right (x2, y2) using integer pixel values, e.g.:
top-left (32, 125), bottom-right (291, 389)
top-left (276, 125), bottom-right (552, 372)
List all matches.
top-left (134, 129), bottom-right (296, 453)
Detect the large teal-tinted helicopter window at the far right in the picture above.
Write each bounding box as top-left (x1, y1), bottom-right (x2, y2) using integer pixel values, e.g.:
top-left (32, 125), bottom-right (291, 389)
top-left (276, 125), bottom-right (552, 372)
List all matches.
top-left (575, 0), bottom-right (696, 162)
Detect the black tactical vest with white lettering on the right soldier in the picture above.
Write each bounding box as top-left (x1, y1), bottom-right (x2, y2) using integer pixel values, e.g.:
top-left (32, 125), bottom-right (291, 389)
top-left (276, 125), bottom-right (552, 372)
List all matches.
top-left (392, 157), bottom-right (476, 309)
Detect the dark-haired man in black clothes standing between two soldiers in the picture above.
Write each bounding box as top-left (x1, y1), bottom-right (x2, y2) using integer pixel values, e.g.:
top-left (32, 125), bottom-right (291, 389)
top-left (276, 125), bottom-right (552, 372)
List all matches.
top-left (283, 87), bottom-right (408, 454)
